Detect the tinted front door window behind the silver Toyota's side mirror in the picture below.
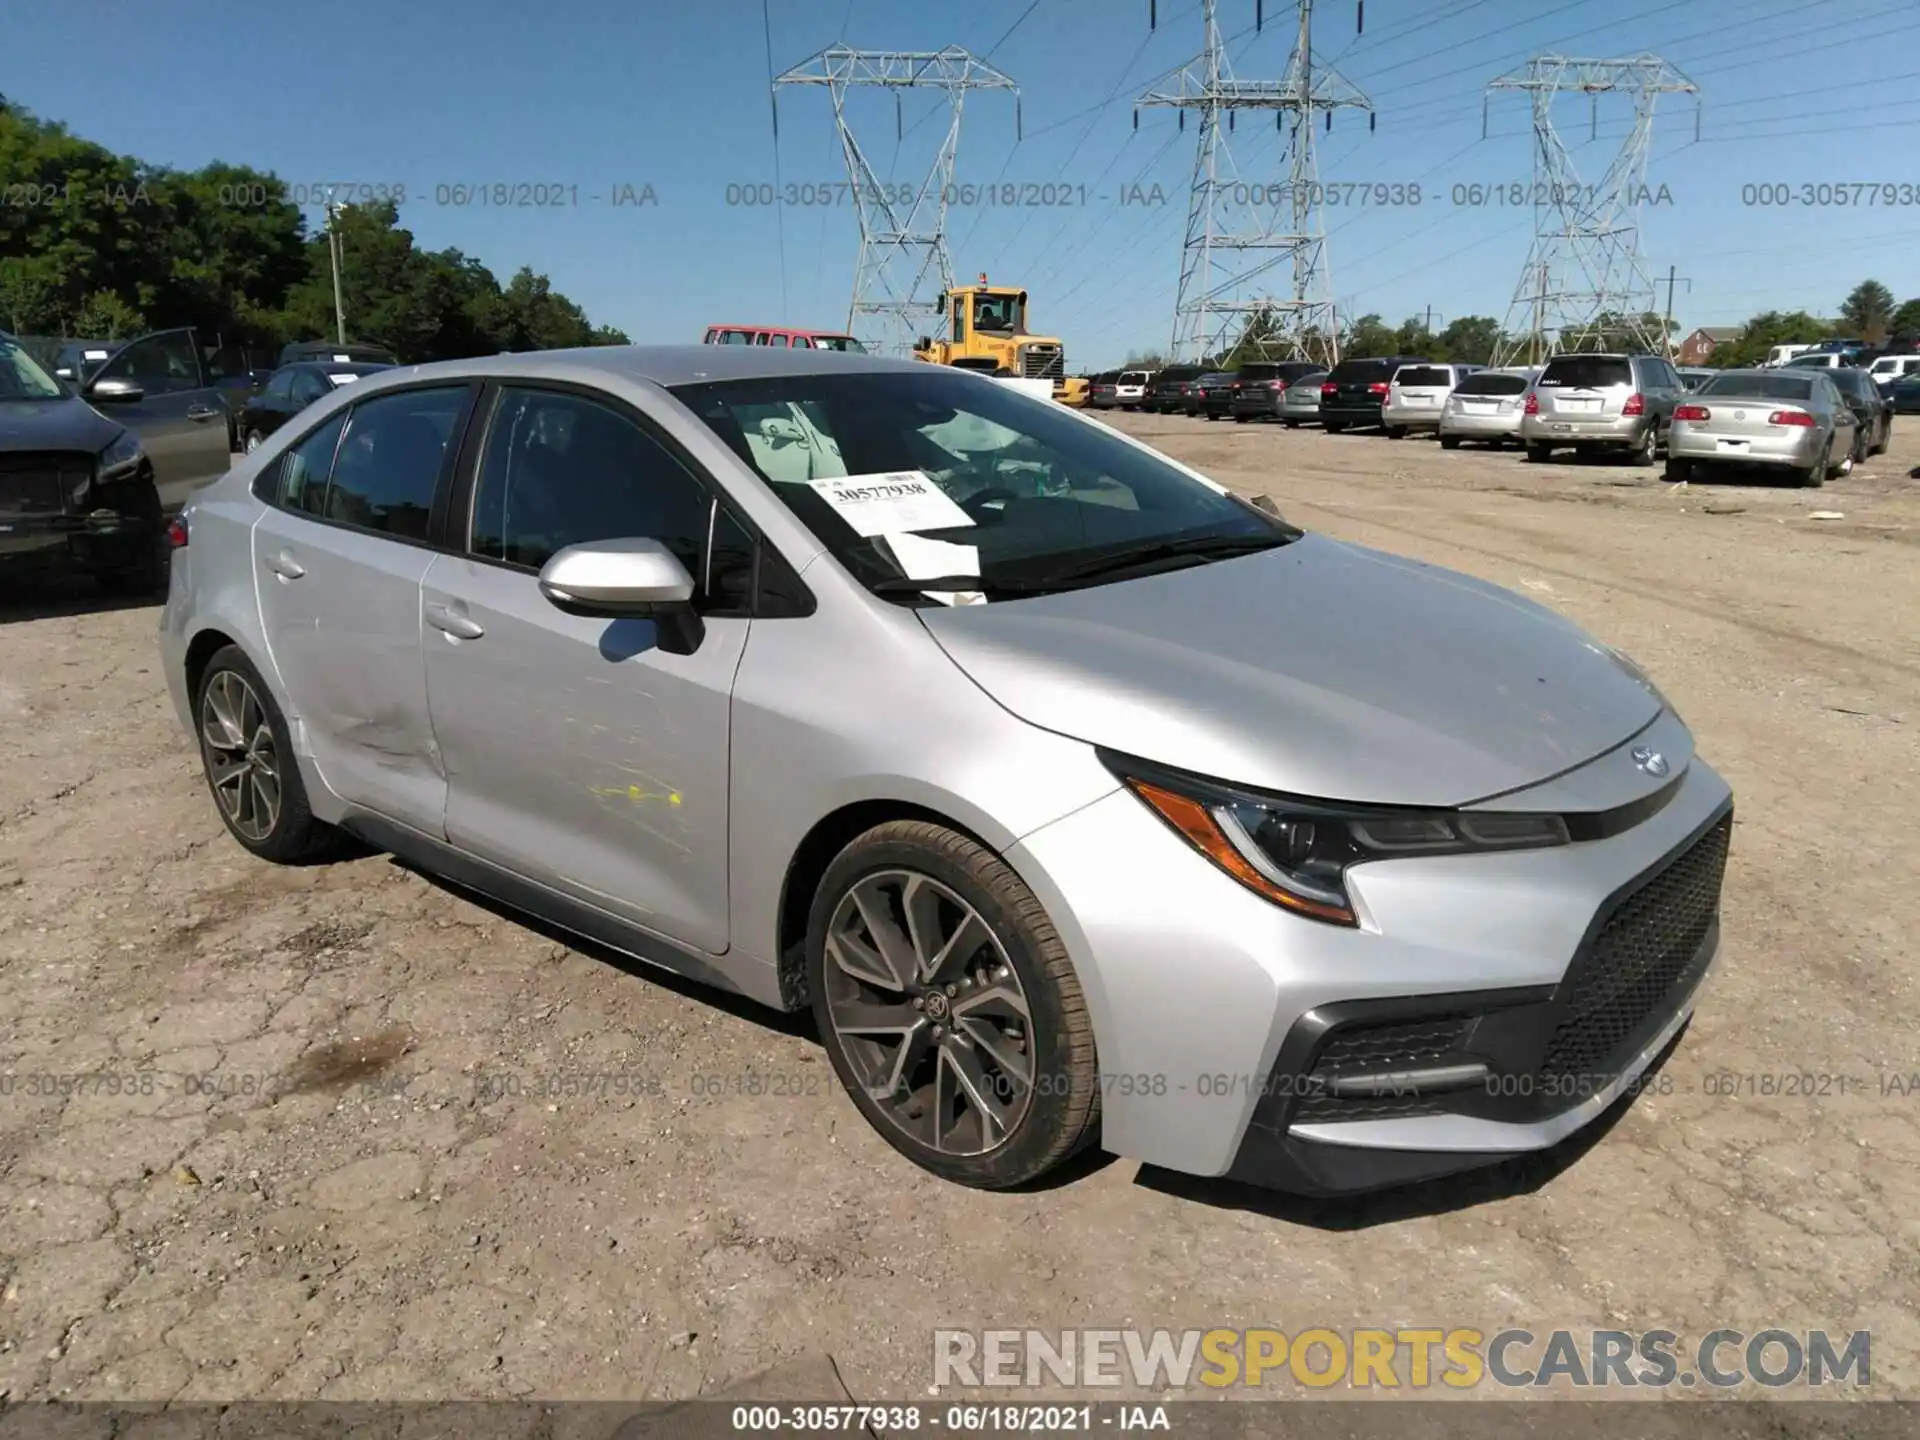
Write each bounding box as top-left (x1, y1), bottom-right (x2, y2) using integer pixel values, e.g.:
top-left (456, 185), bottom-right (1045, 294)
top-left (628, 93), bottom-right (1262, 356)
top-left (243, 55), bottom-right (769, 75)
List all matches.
top-left (470, 386), bottom-right (712, 576)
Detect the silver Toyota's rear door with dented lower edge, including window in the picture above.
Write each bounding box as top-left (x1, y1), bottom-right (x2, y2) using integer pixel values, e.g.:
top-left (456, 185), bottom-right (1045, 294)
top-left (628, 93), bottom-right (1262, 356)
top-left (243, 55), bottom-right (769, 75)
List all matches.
top-left (253, 382), bottom-right (476, 837)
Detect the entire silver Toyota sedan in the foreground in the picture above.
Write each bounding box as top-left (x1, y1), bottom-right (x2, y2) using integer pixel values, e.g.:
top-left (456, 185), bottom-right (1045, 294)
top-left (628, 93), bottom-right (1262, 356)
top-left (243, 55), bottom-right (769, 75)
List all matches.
top-left (161, 346), bottom-right (1732, 1192)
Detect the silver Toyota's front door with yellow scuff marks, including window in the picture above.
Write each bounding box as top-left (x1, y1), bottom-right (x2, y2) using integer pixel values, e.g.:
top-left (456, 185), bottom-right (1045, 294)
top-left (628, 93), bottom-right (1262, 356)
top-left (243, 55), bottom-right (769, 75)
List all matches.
top-left (422, 386), bottom-right (751, 954)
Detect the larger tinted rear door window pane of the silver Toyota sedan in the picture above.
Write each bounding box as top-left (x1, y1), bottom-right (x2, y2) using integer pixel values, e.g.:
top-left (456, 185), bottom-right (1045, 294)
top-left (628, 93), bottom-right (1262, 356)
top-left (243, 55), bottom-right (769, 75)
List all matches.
top-left (326, 386), bottom-right (467, 540)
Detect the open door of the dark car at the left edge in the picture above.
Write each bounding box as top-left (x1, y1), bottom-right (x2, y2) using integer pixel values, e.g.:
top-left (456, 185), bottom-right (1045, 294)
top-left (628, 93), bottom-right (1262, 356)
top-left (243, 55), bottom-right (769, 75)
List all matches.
top-left (90, 330), bottom-right (232, 513)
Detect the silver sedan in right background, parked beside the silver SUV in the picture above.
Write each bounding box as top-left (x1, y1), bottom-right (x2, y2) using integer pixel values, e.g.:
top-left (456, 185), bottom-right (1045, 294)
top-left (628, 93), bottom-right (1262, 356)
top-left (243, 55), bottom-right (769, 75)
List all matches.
top-left (1667, 367), bottom-right (1859, 488)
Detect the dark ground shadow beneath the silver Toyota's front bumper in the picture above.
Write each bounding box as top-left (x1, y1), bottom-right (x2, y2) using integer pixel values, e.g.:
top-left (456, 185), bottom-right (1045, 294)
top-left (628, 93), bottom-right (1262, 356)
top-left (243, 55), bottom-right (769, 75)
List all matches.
top-left (1133, 1021), bottom-right (1692, 1231)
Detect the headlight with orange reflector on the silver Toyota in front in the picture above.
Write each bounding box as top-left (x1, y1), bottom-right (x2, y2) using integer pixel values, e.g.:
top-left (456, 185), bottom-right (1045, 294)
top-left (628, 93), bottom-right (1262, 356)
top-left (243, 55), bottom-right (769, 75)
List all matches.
top-left (1102, 755), bottom-right (1571, 925)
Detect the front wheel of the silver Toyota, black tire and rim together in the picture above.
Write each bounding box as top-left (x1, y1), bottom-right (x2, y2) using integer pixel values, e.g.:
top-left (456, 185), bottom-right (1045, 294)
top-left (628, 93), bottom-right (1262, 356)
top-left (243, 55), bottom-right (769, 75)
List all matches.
top-left (806, 820), bottom-right (1100, 1190)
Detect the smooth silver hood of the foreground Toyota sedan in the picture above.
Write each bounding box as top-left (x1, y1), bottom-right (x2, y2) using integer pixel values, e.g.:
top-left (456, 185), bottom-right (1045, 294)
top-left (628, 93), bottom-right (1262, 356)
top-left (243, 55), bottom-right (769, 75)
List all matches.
top-left (920, 536), bottom-right (1663, 806)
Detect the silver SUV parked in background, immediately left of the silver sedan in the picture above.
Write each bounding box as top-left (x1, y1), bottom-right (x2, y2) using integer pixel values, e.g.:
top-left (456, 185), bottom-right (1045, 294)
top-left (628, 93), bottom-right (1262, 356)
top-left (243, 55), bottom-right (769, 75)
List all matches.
top-left (1521, 355), bottom-right (1686, 465)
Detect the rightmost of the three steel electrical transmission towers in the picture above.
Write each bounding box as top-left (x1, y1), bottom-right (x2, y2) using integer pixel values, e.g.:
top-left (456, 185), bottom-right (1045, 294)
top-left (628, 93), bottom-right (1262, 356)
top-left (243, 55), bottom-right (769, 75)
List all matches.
top-left (1482, 56), bottom-right (1699, 365)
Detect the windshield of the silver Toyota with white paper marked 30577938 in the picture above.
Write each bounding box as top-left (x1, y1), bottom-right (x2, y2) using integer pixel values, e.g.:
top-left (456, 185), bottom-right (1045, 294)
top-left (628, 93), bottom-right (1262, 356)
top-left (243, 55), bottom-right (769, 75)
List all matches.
top-left (674, 367), bottom-right (1300, 597)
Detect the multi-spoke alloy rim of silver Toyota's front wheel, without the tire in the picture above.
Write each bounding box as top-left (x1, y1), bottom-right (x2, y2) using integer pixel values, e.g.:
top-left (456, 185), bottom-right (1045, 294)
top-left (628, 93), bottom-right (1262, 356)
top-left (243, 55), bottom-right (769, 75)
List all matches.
top-left (826, 870), bottom-right (1035, 1156)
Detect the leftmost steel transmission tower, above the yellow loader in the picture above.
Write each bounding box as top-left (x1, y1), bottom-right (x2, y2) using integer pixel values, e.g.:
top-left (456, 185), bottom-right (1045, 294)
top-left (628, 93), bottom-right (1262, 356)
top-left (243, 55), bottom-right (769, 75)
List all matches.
top-left (774, 44), bottom-right (1020, 353)
